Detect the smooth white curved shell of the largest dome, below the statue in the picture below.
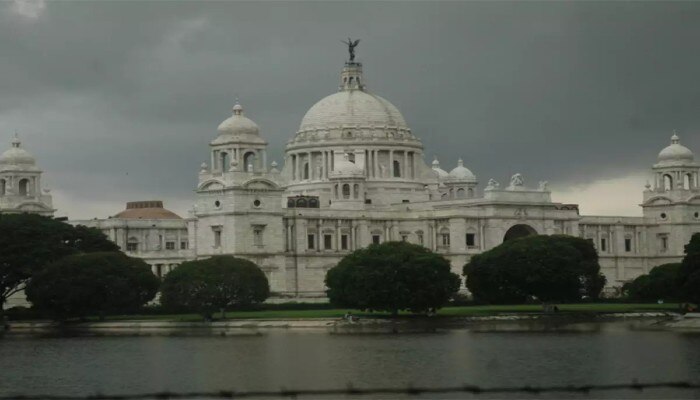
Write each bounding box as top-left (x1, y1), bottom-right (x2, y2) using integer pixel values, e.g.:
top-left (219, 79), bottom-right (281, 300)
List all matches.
top-left (299, 90), bottom-right (408, 131)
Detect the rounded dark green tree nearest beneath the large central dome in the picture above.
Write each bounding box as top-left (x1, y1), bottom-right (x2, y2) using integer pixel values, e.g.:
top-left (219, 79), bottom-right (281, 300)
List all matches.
top-left (326, 242), bottom-right (461, 315)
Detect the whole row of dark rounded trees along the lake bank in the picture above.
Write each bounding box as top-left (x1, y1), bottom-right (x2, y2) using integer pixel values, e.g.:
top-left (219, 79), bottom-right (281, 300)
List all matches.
top-left (0, 214), bottom-right (700, 321)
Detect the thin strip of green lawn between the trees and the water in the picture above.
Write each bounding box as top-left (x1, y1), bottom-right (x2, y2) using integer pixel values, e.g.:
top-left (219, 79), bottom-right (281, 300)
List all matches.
top-left (107, 303), bottom-right (678, 322)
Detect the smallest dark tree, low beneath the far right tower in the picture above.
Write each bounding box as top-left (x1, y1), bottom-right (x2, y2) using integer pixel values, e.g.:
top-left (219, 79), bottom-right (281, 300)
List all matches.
top-left (622, 263), bottom-right (681, 302)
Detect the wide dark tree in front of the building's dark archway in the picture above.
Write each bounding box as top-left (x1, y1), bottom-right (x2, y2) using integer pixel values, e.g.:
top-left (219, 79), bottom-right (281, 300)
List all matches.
top-left (464, 235), bottom-right (605, 304)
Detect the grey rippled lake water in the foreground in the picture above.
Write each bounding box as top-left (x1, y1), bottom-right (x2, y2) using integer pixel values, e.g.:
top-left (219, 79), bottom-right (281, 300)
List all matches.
top-left (0, 322), bottom-right (700, 398)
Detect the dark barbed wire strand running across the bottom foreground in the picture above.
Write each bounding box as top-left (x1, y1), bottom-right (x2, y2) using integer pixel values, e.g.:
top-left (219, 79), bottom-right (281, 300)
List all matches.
top-left (0, 382), bottom-right (700, 400)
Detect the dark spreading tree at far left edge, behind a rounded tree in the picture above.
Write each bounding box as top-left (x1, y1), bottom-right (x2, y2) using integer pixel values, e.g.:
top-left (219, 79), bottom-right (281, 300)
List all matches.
top-left (0, 214), bottom-right (119, 313)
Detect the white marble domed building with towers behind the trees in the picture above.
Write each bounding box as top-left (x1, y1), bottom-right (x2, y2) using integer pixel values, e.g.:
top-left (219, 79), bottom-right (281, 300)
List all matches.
top-left (2, 56), bottom-right (700, 298)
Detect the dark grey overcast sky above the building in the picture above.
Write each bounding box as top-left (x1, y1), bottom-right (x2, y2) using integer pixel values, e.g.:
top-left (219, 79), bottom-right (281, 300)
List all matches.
top-left (0, 1), bottom-right (700, 218)
